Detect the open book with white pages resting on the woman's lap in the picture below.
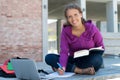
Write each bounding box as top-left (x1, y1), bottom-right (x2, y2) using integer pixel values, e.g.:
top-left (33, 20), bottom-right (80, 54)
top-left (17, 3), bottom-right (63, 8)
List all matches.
top-left (74, 46), bottom-right (104, 58)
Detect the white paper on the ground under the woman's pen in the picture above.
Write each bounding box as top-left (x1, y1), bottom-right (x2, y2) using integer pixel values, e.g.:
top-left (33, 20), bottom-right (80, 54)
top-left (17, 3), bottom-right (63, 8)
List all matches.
top-left (46, 72), bottom-right (75, 79)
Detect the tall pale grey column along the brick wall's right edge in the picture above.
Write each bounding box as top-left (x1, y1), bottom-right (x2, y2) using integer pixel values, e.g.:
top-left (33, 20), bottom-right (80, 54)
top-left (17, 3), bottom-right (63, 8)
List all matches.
top-left (42, 0), bottom-right (48, 62)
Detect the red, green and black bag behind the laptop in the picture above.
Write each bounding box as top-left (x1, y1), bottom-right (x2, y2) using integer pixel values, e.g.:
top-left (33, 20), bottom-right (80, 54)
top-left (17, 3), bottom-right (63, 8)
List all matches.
top-left (0, 59), bottom-right (16, 78)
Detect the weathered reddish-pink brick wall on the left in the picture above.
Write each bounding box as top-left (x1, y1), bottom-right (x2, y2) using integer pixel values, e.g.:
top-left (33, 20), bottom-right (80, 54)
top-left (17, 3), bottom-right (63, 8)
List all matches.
top-left (0, 0), bottom-right (42, 63)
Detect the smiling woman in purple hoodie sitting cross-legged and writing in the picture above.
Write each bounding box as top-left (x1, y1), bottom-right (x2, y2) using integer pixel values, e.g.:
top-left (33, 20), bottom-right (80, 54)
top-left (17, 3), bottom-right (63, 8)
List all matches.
top-left (45, 3), bottom-right (104, 75)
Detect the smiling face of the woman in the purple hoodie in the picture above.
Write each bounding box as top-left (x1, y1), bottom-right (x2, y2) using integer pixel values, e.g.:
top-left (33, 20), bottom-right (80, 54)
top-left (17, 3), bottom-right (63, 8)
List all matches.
top-left (66, 9), bottom-right (82, 27)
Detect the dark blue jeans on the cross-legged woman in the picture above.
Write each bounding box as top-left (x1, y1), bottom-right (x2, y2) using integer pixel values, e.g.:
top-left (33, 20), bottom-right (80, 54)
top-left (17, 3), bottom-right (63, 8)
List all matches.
top-left (45, 51), bottom-right (104, 72)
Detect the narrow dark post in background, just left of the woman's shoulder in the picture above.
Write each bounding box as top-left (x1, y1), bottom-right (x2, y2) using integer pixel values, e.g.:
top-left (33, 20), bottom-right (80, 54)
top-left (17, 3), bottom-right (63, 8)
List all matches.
top-left (56, 19), bottom-right (61, 53)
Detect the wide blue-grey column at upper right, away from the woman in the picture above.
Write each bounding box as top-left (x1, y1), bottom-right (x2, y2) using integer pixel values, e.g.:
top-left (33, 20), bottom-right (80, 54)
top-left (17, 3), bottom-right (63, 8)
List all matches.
top-left (106, 0), bottom-right (118, 32)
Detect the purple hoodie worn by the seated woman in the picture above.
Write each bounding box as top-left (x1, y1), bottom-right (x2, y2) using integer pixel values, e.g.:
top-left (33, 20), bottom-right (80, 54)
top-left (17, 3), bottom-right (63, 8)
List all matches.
top-left (59, 20), bottom-right (104, 67)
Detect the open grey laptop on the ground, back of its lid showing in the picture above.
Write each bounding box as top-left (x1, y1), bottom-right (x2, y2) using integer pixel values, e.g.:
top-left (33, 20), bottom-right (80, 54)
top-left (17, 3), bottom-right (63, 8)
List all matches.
top-left (10, 58), bottom-right (47, 80)
